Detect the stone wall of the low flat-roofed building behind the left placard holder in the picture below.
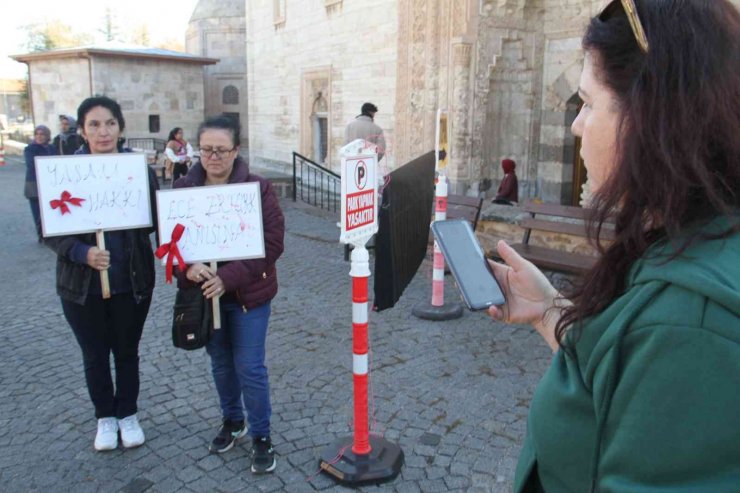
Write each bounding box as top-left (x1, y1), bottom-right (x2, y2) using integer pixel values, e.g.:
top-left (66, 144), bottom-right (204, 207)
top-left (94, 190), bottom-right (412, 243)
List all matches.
top-left (92, 57), bottom-right (204, 143)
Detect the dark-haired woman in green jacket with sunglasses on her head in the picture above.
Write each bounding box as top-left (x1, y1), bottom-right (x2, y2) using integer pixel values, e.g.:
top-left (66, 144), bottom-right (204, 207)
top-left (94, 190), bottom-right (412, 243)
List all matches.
top-left (490, 0), bottom-right (740, 493)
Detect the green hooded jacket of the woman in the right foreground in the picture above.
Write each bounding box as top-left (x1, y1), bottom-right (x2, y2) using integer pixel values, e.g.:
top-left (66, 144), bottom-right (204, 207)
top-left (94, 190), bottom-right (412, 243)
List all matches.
top-left (514, 224), bottom-right (740, 493)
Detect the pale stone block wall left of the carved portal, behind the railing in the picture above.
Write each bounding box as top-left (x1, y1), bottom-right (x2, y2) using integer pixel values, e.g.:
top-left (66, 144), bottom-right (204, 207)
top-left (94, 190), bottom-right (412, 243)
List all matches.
top-left (247, 0), bottom-right (398, 170)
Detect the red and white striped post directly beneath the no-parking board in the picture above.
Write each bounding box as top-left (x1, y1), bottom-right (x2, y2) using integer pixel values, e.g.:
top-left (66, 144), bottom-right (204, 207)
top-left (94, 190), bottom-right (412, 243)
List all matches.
top-left (349, 246), bottom-right (372, 454)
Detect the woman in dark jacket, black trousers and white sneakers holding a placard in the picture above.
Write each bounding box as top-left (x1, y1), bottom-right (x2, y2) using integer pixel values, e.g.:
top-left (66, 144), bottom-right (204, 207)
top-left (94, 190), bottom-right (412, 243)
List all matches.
top-left (45, 96), bottom-right (158, 451)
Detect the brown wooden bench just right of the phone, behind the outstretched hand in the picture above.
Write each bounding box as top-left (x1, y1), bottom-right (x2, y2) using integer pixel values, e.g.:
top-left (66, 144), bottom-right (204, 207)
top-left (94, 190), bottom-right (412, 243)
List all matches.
top-left (494, 202), bottom-right (614, 274)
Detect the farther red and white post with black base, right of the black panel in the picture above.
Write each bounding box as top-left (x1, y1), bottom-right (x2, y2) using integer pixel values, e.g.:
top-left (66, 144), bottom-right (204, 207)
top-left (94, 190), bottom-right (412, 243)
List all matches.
top-left (411, 109), bottom-right (463, 321)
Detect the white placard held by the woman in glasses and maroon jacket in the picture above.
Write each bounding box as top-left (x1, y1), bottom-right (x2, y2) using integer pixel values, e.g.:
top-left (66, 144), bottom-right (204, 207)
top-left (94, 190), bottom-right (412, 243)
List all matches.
top-left (157, 182), bottom-right (265, 263)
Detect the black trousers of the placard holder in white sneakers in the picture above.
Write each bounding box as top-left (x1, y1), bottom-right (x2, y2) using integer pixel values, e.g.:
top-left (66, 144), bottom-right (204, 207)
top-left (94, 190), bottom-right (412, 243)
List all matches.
top-left (62, 293), bottom-right (152, 419)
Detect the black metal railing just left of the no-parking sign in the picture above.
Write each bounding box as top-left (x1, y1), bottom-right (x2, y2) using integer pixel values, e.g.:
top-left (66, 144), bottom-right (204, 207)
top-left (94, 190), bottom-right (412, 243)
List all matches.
top-left (293, 152), bottom-right (342, 212)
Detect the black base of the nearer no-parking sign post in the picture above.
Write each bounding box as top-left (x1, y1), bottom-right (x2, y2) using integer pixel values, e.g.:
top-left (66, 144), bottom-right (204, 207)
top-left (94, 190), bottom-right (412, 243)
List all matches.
top-left (319, 436), bottom-right (403, 486)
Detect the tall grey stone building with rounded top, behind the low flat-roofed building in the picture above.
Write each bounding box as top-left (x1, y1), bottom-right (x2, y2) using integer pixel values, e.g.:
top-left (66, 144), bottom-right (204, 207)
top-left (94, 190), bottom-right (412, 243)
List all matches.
top-left (185, 0), bottom-right (249, 150)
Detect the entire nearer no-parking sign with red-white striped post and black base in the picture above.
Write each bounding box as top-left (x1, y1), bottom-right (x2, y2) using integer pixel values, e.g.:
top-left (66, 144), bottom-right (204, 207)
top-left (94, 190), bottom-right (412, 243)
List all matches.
top-left (319, 139), bottom-right (404, 486)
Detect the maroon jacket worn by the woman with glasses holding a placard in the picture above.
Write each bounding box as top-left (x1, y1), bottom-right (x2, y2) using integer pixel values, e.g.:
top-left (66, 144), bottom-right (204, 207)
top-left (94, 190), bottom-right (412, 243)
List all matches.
top-left (173, 157), bottom-right (285, 308)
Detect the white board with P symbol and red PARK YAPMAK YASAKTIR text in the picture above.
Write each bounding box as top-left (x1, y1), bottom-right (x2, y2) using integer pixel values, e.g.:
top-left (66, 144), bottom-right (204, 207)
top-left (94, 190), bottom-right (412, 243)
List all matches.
top-left (339, 154), bottom-right (378, 245)
